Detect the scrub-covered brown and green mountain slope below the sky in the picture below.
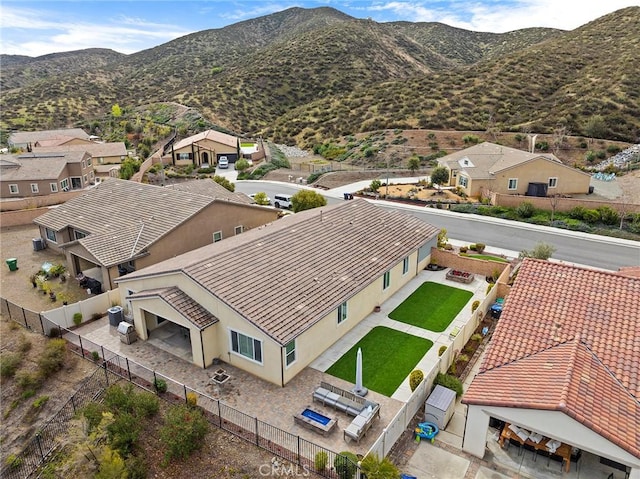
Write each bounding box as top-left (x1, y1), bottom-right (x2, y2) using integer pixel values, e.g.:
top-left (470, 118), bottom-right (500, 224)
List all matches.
top-left (0, 7), bottom-right (640, 145)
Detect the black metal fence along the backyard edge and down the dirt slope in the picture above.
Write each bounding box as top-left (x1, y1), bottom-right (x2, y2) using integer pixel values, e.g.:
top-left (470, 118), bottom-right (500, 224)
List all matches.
top-left (0, 298), bottom-right (359, 479)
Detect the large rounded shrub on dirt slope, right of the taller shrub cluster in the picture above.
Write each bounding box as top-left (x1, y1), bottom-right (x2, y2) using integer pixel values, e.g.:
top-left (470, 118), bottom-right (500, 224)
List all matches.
top-left (160, 404), bottom-right (209, 462)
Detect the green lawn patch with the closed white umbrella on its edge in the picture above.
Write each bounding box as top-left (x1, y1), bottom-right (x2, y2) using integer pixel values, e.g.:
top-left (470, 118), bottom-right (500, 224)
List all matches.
top-left (327, 326), bottom-right (433, 396)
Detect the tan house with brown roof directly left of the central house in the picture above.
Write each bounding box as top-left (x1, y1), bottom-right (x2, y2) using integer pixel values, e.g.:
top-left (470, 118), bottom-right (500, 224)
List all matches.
top-left (34, 179), bottom-right (278, 289)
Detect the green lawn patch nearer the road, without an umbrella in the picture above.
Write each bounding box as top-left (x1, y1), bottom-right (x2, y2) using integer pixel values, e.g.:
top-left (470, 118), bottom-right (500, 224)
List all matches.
top-left (389, 281), bottom-right (473, 332)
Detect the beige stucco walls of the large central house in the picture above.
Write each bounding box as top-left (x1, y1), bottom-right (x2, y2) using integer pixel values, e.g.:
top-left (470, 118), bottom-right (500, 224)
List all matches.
top-left (118, 244), bottom-right (435, 386)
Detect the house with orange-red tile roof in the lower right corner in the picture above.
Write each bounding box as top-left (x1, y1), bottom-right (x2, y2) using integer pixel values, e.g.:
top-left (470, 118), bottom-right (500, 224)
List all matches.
top-left (462, 259), bottom-right (640, 478)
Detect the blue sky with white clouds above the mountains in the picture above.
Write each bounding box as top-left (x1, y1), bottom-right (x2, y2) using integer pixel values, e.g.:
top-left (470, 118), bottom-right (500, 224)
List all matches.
top-left (0, 0), bottom-right (640, 56)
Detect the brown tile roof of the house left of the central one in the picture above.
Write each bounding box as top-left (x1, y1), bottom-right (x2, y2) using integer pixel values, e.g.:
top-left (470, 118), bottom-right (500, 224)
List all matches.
top-left (34, 179), bottom-right (250, 266)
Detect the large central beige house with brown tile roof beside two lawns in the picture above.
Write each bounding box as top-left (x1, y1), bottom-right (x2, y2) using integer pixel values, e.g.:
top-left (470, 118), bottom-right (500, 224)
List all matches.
top-left (117, 200), bottom-right (439, 386)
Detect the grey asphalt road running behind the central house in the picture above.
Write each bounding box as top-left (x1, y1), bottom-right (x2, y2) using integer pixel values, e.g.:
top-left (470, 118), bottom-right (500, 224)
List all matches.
top-left (236, 181), bottom-right (640, 270)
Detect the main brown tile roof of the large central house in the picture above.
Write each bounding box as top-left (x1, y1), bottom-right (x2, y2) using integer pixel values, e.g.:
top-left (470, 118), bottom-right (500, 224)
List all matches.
top-left (122, 200), bottom-right (439, 345)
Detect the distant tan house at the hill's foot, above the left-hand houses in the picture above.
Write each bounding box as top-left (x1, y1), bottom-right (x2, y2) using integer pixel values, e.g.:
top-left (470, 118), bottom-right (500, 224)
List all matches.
top-left (171, 130), bottom-right (240, 166)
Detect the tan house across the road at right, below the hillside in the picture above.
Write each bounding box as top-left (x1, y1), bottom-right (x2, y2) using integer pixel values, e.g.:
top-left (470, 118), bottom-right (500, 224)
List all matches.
top-left (438, 142), bottom-right (591, 197)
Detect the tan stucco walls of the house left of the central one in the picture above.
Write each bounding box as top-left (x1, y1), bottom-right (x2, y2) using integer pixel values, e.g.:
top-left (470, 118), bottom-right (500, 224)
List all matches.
top-left (40, 201), bottom-right (278, 289)
